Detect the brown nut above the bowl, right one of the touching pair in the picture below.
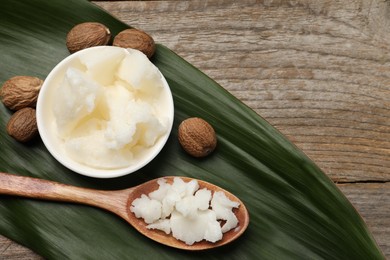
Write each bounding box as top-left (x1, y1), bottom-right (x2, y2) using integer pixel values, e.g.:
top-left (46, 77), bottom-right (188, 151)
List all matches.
top-left (112, 29), bottom-right (156, 59)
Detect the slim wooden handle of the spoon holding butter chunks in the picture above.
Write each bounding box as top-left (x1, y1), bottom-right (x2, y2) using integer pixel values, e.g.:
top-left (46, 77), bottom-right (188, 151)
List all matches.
top-left (0, 172), bottom-right (129, 217)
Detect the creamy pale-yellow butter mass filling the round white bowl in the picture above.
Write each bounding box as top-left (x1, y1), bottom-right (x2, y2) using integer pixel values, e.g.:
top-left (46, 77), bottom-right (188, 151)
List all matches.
top-left (53, 48), bottom-right (169, 169)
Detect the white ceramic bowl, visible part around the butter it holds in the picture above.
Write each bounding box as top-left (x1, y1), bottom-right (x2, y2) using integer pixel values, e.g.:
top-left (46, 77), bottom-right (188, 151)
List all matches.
top-left (36, 46), bottom-right (174, 178)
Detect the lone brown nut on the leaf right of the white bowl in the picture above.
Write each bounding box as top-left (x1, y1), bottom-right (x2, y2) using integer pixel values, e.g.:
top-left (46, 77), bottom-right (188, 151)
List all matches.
top-left (178, 117), bottom-right (217, 157)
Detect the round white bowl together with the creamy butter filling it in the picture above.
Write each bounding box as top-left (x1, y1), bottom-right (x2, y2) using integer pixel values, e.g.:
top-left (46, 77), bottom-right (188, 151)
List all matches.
top-left (37, 46), bottom-right (174, 178)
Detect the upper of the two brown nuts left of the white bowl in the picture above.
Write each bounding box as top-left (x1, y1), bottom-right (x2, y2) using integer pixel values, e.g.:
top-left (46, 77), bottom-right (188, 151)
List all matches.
top-left (0, 76), bottom-right (43, 110)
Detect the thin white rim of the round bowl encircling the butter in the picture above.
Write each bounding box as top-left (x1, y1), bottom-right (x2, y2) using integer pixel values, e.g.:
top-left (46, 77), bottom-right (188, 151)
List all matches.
top-left (36, 46), bottom-right (175, 178)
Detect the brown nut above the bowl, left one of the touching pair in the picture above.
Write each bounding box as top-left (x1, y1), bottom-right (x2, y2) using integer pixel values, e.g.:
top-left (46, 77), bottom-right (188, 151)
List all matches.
top-left (66, 22), bottom-right (111, 53)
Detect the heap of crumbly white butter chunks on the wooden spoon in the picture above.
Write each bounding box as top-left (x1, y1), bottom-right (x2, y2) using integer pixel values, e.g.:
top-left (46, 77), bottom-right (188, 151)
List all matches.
top-left (130, 177), bottom-right (239, 245)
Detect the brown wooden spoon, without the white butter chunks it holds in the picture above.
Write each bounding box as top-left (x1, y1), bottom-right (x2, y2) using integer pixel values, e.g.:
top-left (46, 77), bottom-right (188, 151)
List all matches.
top-left (0, 173), bottom-right (249, 250)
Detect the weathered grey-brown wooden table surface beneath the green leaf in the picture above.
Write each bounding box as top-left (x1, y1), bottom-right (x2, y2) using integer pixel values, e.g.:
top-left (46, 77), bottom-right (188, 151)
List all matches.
top-left (0, 0), bottom-right (390, 260)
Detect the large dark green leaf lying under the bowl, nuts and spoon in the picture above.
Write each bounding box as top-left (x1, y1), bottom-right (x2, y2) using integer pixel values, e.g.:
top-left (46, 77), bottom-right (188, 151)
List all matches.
top-left (0, 0), bottom-right (384, 259)
